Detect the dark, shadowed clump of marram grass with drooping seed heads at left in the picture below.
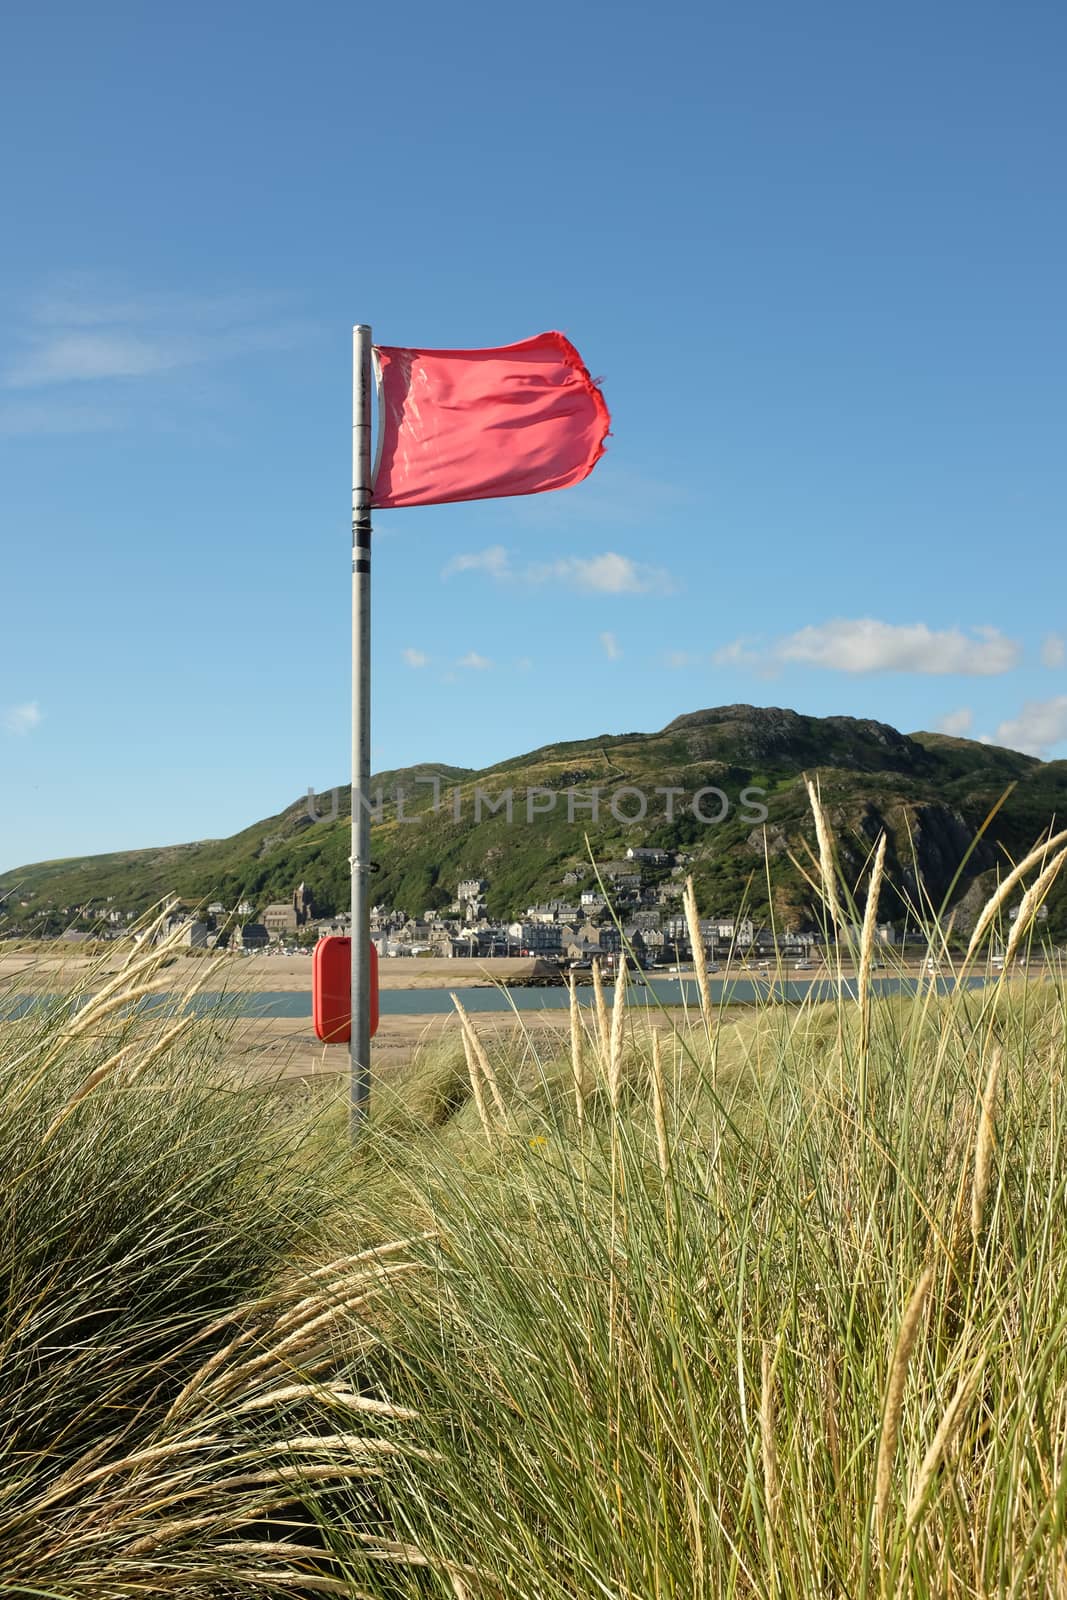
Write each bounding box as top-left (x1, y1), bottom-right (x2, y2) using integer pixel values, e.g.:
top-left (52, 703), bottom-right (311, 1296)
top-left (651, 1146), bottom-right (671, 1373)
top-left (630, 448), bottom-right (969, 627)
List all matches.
top-left (0, 942), bottom-right (428, 1600)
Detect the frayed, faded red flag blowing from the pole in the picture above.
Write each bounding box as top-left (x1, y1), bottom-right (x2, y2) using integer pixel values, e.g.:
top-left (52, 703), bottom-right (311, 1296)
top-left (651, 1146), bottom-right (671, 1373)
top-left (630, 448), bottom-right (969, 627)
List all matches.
top-left (373, 333), bottom-right (611, 509)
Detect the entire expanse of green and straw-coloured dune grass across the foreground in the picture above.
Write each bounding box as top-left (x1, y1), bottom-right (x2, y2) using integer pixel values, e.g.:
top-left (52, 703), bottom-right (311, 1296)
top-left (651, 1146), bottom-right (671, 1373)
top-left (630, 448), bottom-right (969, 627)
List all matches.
top-left (0, 812), bottom-right (1067, 1600)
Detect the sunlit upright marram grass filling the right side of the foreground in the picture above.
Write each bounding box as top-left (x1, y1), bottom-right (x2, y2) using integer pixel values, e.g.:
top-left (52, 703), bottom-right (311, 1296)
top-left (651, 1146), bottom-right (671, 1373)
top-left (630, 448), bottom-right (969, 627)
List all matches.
top-left (326, 960), bottom-right (1067, 1600)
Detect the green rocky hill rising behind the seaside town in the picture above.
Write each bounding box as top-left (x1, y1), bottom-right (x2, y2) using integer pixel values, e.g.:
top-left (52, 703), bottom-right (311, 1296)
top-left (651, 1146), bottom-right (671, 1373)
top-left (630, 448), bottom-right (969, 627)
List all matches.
top-left (0, 706), bottom-right (1067, 938)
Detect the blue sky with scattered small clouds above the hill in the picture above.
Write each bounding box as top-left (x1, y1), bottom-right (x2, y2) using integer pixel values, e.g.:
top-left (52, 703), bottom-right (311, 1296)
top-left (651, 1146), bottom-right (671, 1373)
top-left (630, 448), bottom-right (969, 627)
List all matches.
top-left (0, 0), bottom-right (1067, 869)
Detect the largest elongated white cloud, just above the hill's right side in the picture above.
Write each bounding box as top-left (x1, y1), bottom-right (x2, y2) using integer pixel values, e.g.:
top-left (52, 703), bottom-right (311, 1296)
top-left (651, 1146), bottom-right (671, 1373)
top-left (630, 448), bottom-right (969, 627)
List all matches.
top-left (715, 618), bottom-right (1021, 677)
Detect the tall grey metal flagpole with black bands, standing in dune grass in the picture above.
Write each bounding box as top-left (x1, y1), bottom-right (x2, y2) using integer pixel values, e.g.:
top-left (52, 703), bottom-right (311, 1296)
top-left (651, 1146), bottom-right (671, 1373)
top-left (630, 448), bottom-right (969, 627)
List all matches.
top-left (349, 323), bottom-right (371, 1138)
